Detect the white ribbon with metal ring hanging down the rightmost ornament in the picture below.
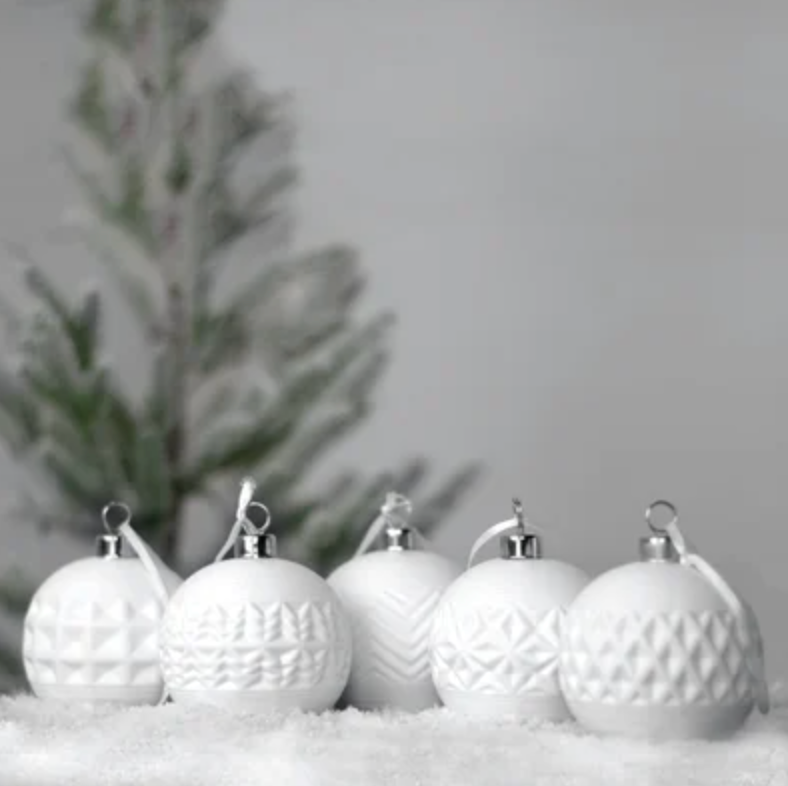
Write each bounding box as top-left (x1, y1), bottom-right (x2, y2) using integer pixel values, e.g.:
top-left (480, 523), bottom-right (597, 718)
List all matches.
top-left (646, 501), bottom-right (771, 715)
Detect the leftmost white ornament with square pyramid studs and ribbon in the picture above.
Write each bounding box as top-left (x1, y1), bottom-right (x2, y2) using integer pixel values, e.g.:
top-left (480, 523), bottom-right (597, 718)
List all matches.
top-left (22, 503), bottom-right (181, 705)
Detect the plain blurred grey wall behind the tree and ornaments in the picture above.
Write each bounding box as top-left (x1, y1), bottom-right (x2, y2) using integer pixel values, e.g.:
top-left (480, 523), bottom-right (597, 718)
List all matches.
top-left (0, 0), bottom-right (788, 678)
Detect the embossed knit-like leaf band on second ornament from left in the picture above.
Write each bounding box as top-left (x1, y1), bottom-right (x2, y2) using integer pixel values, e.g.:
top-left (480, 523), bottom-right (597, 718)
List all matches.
top-left (161, 601), bottom-right (351, 690)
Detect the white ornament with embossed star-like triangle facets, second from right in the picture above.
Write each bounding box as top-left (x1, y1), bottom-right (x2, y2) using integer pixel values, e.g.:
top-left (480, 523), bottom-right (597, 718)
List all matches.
top-left (431, 500), bottom-right (589, 721)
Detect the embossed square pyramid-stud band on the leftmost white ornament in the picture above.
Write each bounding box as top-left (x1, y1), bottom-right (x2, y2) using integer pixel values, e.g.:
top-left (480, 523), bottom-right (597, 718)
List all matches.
top-left (23, 594), bottom-right (162, 687)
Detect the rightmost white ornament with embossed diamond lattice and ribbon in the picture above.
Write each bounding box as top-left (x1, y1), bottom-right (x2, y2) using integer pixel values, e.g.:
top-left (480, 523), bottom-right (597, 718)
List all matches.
top-left (560, 501), bottom-right (769, 739)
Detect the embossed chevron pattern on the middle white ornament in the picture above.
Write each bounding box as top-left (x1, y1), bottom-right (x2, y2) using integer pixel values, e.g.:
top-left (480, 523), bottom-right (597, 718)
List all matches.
top-left (350, 589), bottom-right (442, 684)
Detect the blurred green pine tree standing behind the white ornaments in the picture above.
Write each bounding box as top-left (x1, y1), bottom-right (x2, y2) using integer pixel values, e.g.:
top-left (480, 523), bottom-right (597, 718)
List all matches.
top-left (0, 0), bottom-right (477, 688)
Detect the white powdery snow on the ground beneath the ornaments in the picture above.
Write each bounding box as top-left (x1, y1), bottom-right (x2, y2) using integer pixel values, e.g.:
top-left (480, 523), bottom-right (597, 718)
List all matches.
top-left (0, 689), bottom-right (788, 786)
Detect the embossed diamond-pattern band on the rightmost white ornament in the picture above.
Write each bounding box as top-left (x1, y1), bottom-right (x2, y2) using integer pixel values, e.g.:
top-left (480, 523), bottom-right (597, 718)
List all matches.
top-left (561, 611), bottom-right (754, 706)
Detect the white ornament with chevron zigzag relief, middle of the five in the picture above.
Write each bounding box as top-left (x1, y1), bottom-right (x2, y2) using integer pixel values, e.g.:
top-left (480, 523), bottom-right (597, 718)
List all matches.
top-left (328, 494), bottom-right (460, 712)
